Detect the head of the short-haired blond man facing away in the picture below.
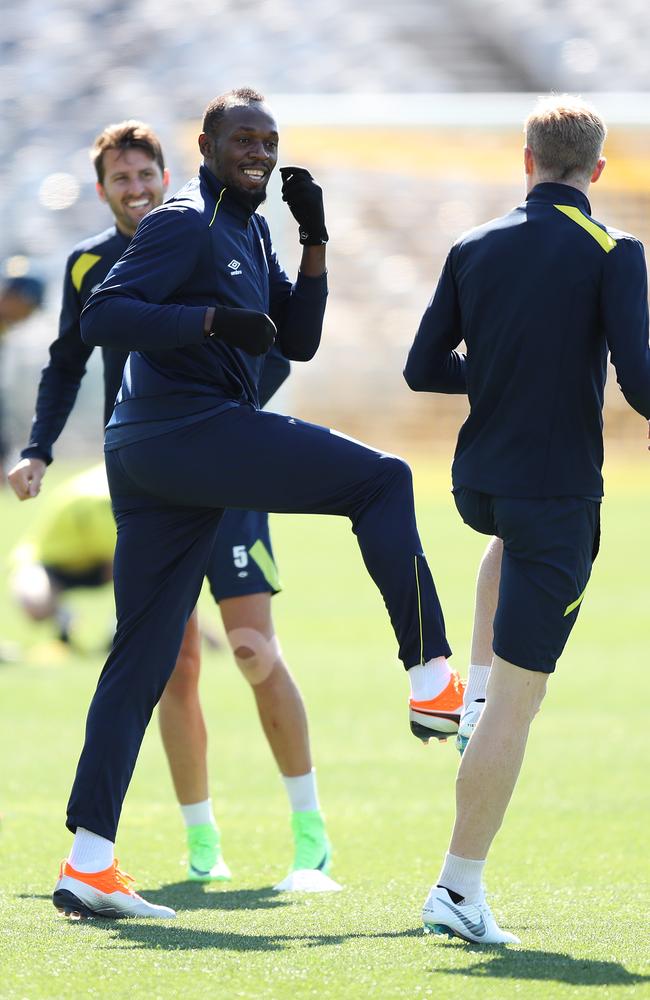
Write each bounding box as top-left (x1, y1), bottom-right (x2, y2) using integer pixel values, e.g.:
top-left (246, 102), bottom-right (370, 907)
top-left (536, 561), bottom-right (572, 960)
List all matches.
top-left (524, 94), bottom-right (607, 181)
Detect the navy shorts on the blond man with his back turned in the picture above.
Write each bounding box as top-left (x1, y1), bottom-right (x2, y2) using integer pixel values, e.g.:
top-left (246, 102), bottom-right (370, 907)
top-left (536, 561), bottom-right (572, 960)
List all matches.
top-left (454, 487), bottom-right (600, 674)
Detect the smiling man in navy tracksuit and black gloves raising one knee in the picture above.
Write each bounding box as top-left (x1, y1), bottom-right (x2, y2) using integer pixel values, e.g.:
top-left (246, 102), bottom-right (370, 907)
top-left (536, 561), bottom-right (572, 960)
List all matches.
top-left (54, 90), bottom-right (462, 917)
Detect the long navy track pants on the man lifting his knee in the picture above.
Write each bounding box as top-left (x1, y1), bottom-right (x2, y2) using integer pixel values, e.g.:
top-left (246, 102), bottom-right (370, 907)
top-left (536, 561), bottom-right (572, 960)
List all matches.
top-left (67, 406), bottom-right (451, 840)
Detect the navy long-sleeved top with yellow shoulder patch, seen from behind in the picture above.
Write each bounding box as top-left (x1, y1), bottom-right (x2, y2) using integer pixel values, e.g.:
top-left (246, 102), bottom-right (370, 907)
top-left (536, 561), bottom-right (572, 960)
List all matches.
top-left (404, 183), bottom-right (650, 497)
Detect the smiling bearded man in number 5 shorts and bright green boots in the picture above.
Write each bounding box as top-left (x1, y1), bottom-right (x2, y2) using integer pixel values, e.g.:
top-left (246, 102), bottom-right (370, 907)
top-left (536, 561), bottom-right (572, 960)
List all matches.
top-left (9, 119), bottom-right (331, 882)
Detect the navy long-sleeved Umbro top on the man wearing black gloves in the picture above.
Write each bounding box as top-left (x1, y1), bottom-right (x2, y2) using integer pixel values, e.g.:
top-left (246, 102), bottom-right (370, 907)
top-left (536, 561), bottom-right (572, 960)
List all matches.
top-left (81, 167), bottom-right (327, 449)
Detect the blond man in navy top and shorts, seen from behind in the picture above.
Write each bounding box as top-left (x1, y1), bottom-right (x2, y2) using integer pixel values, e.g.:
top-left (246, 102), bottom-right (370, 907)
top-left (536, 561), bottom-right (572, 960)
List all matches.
top-left (405, 96), bottom-right (650, 943)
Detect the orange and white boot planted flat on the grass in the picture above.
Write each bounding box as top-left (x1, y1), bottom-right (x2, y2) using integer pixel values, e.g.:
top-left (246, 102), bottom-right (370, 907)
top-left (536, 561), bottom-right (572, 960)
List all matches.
top-left (52, 859), bottom-right (176, 920)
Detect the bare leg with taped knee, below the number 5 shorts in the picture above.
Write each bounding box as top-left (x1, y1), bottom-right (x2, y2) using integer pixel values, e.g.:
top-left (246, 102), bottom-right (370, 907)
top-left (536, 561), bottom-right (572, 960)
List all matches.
top-left (219, 593), bottom-right (312, 777)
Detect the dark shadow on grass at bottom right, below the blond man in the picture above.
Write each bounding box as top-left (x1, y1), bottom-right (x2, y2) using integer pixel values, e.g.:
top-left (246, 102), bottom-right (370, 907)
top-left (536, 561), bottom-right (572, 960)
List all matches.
top-left (431, 942), bottom-right (650, 986)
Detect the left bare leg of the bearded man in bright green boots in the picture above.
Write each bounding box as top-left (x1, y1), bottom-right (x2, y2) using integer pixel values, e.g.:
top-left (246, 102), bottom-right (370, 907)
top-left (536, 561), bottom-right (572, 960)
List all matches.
top-left (158, 610), bottom-right (210, 805)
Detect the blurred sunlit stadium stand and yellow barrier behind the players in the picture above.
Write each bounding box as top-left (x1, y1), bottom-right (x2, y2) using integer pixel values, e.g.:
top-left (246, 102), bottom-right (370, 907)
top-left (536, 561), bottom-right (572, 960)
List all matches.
top-left (0, 0), bottom-right (650, 458)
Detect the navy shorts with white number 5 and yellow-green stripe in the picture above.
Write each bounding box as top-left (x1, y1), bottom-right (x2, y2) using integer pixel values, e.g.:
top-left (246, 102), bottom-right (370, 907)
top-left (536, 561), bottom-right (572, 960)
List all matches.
top-left (205, 510), bottom-right (281, 602)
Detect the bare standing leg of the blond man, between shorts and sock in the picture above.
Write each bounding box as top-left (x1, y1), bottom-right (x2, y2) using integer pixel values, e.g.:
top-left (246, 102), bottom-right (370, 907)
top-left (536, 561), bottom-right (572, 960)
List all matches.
top-left (449, 656), bottom-right (548, 860)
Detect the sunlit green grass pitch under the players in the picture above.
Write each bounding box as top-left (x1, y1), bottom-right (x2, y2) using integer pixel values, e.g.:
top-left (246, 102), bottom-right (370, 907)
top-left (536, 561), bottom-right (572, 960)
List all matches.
top-left (0, 456), bottom-right (650, 1000)
